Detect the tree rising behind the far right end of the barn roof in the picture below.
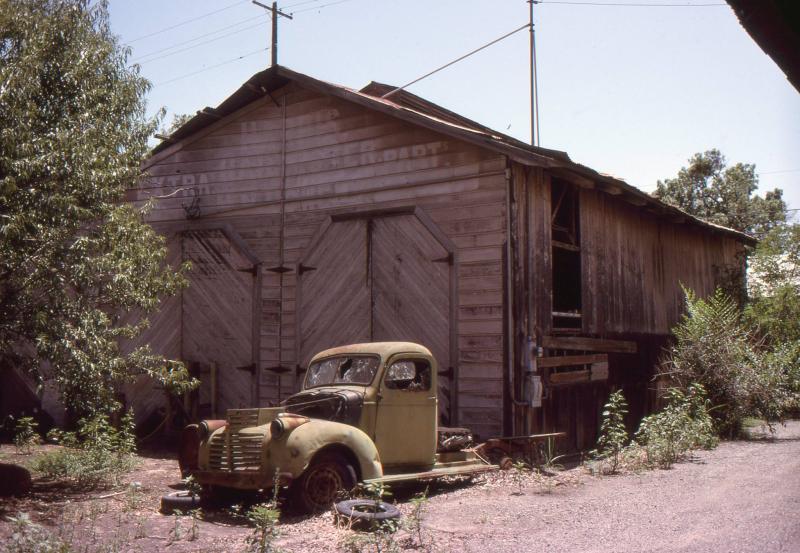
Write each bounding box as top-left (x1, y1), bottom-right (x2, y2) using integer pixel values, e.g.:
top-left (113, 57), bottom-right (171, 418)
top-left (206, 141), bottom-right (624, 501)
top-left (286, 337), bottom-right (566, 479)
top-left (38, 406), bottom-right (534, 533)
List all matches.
top-left (653, 150), bottom-right (786, 237)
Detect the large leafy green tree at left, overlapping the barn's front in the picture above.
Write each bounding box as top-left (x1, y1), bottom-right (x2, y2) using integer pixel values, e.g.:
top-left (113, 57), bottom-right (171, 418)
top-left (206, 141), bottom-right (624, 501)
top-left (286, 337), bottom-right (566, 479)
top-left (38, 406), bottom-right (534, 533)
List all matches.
top-left (0, 0), bottom-right (194, 414)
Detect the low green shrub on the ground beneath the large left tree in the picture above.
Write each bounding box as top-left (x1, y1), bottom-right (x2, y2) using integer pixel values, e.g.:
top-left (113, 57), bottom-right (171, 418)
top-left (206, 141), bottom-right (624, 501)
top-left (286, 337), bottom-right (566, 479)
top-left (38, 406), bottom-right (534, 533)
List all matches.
top-left (31, 411), bottom-right (136, 488)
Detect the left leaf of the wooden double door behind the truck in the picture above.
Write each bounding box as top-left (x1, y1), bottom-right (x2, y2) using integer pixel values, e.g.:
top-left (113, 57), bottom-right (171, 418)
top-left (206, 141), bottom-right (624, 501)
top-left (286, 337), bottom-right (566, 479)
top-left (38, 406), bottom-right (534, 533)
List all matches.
top-left (297, 219), bottom-right (370, 368)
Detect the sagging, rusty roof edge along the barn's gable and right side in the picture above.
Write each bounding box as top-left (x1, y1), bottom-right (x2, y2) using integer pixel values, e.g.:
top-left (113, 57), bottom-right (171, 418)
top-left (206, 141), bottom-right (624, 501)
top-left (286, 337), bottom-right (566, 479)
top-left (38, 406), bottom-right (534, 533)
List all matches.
top-left (142, 66), bottom-right (757, 246)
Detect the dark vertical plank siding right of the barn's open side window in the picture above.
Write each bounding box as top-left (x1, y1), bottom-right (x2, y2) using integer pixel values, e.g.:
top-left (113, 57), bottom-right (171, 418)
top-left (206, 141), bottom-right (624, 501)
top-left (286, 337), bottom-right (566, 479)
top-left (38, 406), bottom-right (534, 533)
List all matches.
top-left (580, 190), bottom-right (741, 336)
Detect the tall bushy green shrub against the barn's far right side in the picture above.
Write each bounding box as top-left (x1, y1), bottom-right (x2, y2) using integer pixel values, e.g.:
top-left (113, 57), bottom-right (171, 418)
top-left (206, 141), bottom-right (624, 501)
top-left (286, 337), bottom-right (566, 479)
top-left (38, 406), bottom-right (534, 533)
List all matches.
top-left (665, 290), bottom-right (788, 436)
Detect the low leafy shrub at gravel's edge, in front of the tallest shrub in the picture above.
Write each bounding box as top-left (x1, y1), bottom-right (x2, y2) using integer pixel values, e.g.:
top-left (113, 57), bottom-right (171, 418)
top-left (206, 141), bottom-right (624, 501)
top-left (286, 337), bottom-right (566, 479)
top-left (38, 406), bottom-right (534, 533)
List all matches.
top-left (633, 384), bottom-right (718, 468)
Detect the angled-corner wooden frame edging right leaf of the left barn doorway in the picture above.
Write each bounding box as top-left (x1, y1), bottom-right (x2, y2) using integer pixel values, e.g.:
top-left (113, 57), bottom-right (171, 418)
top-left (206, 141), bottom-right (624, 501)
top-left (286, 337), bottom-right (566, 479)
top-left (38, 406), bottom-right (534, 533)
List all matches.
top-left (177, 221), bottom-right (263, 406)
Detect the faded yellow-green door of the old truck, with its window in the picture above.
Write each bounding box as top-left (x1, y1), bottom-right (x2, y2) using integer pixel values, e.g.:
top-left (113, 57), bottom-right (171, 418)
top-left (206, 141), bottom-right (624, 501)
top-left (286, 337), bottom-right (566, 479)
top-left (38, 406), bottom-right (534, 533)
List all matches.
top-left (375, 355), bottom-right (437, 469)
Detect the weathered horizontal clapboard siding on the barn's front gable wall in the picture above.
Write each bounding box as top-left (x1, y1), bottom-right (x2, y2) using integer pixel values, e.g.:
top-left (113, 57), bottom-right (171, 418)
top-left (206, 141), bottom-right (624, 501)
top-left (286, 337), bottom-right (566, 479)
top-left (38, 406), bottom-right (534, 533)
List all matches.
top-left (141, 84), bottom-right (506, 435)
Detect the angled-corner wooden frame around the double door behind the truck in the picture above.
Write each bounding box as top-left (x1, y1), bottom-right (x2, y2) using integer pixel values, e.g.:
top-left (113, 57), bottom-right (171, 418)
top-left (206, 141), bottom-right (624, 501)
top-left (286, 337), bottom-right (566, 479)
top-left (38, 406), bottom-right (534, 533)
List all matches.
top-left (295, 205), bottom-right (459, 426)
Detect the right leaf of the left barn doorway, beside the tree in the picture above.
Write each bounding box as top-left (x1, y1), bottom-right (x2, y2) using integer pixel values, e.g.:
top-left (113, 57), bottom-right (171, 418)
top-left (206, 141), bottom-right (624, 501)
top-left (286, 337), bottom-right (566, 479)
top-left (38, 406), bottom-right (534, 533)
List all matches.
top-left (181, 229), bottom-right (256, 416)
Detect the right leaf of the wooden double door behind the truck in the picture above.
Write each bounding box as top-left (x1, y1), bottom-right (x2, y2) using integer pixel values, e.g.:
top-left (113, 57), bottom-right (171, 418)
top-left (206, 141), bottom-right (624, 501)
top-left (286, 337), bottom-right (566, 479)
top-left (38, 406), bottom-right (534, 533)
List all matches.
top-left (371, 215), bottom-right (451, 424)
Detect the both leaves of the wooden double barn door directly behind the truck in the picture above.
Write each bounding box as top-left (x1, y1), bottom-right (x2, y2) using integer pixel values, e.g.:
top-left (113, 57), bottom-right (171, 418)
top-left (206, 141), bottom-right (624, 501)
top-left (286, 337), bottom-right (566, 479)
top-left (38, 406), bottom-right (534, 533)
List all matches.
top-left (298, 213), bottom-right (454, 423)
